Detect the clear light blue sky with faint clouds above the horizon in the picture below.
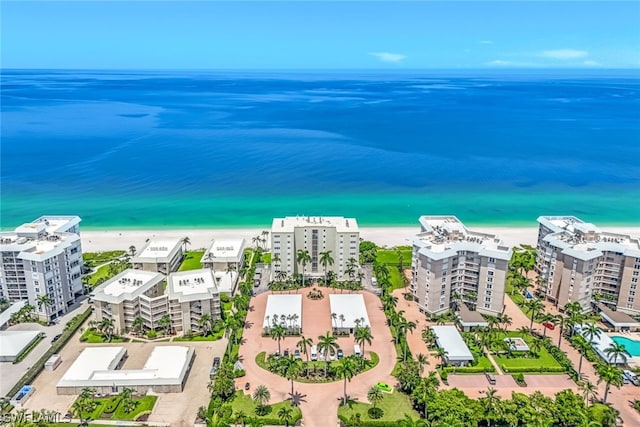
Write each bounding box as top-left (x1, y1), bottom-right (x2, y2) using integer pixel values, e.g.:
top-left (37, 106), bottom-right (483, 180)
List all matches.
top-left (0, 0), bottom-right (640, 70)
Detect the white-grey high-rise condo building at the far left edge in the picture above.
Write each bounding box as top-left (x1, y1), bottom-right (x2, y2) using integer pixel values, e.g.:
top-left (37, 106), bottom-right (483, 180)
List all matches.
top-left (0, 216), bottom-right (83, 321)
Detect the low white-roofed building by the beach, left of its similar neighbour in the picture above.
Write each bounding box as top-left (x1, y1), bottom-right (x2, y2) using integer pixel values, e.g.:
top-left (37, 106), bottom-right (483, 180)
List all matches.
top-left (131, 238), bottom-right (182, 274)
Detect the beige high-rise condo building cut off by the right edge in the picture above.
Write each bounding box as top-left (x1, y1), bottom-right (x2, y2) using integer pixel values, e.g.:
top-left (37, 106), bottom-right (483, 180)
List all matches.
top-left (535, 216), bottom-right (640, 314)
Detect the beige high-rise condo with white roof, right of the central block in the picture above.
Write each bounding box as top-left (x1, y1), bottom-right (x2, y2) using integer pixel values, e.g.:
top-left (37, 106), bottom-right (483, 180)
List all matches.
top-left (411, 216), bottom-right (512, 315)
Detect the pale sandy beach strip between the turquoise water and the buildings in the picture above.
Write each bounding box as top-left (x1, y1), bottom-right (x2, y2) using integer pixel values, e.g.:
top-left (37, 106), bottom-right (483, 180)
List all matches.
top-left (80, 226), bottom-right (640, 252)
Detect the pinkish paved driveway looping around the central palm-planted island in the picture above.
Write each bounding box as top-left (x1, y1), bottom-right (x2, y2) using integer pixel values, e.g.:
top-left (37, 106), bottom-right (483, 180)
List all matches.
top-left (236, 288), bottom-right (397, 427)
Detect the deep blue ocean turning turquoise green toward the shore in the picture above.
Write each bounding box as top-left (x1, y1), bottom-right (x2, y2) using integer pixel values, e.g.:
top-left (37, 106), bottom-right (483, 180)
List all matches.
top-left (0, 70), bottom-right (640, 229)
